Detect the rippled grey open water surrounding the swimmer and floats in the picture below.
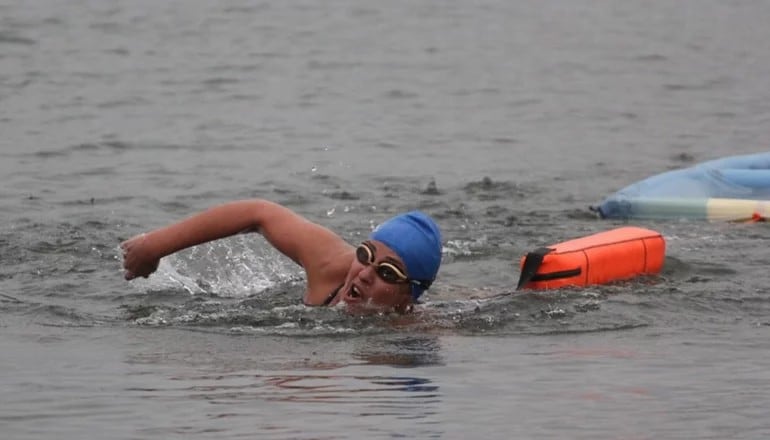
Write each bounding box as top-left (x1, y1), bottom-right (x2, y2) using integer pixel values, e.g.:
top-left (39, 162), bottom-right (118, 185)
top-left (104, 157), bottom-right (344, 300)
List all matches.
top-left (0, 0), bottom-right (770, 439)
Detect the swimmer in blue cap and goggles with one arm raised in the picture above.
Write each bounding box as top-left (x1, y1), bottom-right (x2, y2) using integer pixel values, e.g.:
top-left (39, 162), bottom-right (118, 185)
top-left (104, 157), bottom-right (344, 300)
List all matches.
top-left (120, 199), bottom-right (441, 314)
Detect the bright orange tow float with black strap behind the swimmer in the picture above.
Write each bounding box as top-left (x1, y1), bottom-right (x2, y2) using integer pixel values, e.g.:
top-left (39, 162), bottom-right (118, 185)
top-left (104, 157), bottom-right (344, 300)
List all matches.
top-left (517, 226), bottom-right (666, 290)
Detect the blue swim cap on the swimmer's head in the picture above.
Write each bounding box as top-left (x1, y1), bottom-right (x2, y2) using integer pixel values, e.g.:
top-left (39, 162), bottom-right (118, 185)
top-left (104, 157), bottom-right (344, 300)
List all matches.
top-left (369, 211), bottom-right (441, 299)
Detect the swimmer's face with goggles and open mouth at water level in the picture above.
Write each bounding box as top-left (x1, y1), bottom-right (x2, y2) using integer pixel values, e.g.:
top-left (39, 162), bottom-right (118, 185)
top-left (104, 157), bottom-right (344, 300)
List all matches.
top-left (332, 240), bottom-right (412, 314)
